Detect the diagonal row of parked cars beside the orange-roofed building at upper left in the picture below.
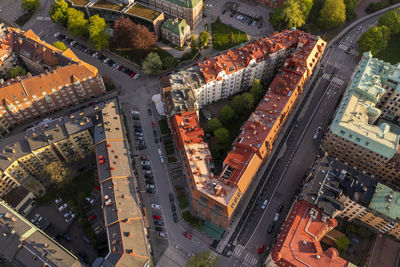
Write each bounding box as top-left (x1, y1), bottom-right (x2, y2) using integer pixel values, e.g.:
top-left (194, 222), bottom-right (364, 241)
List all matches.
top-left (54, 32), bottom-right (140, 79)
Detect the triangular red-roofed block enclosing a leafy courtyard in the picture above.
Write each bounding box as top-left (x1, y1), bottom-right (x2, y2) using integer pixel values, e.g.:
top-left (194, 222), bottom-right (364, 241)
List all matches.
top-left (164, 30), bottom-right (326, 227)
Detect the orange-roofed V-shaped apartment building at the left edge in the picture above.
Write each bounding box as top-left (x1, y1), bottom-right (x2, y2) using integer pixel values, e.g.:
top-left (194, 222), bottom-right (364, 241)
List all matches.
top-left (0, 28), bottom-right (105, 136)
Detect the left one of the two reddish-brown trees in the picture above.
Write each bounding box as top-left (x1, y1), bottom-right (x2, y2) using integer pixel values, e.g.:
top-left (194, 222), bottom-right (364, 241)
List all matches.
top-left (113, 16), bottom-right (135, 48)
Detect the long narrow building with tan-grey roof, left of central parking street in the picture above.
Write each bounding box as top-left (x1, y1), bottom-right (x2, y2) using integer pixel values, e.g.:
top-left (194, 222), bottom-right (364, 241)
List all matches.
top-left (94, 99), bottom-right (150, 266)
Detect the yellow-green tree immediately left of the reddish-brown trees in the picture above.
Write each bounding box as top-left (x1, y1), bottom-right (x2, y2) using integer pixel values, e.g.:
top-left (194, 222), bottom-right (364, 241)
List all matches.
top-left (89, 15), bottom-right (110, 50)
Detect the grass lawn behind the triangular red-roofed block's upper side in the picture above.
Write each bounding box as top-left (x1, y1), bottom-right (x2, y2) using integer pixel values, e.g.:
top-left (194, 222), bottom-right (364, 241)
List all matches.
top-left (211, 22), bottom-right (248, 51)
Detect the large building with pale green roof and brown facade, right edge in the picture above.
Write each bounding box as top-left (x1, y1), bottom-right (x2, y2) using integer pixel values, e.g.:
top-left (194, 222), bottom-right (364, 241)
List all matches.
top-left (322, 52), bottom-right (400, 188)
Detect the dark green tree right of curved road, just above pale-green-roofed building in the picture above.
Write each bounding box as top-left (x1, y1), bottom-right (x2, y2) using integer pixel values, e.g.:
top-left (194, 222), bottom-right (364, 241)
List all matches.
top-left (358, 26), bottom-right (390, 56)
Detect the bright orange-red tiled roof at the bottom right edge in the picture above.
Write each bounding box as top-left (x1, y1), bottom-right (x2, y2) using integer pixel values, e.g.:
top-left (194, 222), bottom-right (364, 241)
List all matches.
top-left (272, 201), bottom-right (349, 267)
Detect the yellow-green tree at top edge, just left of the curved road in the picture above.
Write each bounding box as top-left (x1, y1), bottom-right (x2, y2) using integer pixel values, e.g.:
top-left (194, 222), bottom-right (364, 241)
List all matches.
top-left (319, 0), bottom-right (346, 29)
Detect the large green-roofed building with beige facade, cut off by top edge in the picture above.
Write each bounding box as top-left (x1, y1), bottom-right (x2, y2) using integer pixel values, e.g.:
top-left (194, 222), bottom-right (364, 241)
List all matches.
top-left (145, 0), bottom-right (203, 29)
